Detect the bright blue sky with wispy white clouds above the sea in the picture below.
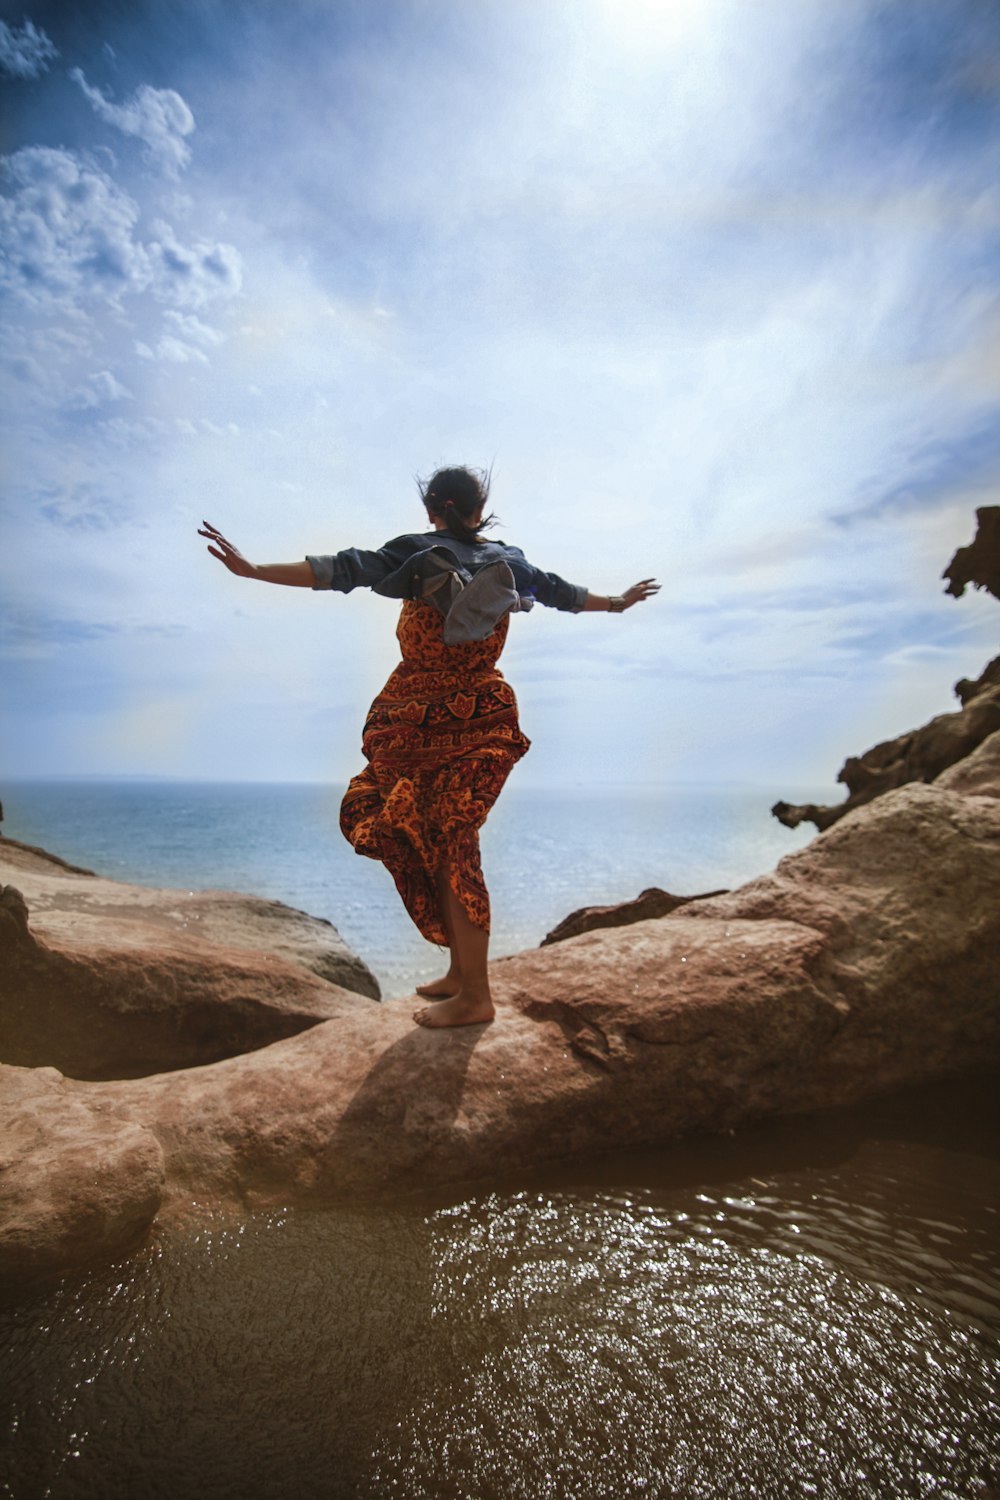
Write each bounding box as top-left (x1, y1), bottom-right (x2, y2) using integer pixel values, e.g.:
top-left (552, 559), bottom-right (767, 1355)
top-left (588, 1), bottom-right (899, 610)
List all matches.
top-left (0, 0), bottom-right (1000, 798)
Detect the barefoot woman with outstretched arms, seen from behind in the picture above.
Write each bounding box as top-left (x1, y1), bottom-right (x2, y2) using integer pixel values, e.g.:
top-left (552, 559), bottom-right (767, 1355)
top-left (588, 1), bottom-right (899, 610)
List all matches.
top-left (198, 468), bottom-right (660, 1026)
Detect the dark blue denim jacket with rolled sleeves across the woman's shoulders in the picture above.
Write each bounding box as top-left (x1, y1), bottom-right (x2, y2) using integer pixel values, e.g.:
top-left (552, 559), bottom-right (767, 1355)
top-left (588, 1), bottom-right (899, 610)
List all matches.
top-left (306, 531), bottom-right (588, 614)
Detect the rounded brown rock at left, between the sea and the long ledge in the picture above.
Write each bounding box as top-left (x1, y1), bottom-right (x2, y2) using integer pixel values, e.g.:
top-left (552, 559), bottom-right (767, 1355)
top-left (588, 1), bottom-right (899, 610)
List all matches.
top-left (0, 840), bottom-right (378, 1079)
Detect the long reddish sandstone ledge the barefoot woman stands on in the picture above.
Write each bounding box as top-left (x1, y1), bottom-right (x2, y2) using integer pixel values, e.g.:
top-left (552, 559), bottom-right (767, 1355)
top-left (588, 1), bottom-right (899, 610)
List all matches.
top-left (0, 734), bottom-right (1000, 1269)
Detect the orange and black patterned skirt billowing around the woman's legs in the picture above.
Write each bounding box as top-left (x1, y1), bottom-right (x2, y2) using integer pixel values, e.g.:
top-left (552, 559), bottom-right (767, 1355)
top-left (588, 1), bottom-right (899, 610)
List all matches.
top-left (340, 600), bottom-right (529, 945)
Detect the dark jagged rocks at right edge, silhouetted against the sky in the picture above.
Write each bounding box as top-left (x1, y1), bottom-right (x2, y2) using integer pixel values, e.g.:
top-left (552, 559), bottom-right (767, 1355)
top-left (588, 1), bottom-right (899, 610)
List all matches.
top-left (771, 506), bottom-right (1000, 833)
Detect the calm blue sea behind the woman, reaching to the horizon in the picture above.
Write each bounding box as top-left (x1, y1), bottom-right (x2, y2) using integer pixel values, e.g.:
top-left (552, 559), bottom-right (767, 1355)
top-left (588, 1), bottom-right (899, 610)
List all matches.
top-left (0, 782), bottom-right (831, 999)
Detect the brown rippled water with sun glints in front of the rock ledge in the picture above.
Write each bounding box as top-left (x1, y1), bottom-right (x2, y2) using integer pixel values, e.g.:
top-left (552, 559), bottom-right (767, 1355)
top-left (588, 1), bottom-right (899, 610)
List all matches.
top-left (3, 1085), bottom-right (1000, 1500)
